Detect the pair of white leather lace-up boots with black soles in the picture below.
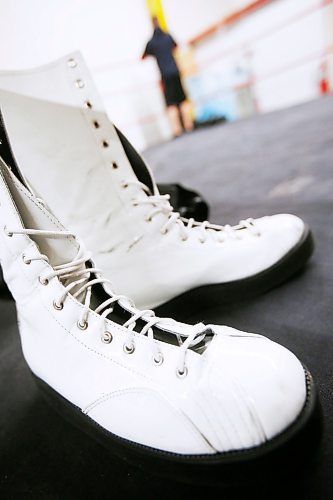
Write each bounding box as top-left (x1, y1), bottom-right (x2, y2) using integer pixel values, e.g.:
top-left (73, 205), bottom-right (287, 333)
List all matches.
top-left (0, 53), bottom-right (315, 474)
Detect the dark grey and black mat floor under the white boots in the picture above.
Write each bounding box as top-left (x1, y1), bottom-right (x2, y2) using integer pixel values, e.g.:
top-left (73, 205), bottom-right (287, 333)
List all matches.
top-left (0, 97), bottom-right (333, 500)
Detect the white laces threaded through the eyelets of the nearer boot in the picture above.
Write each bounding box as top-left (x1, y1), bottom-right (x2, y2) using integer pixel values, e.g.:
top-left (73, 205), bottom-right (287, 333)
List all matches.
top-left (5, 228), bottom-right (207, 377)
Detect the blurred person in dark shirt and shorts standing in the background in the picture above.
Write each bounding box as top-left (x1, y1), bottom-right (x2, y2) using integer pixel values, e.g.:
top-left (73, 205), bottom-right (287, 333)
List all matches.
top-left (142, 17), bottom-right (193, 137)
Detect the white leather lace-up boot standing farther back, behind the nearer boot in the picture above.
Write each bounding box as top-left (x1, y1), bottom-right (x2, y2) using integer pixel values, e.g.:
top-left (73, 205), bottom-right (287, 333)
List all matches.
top-left (0, 53), bottom-right (313, 318)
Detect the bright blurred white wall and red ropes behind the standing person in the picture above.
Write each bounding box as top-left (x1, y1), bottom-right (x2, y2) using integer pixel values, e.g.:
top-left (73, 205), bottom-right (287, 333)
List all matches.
top-left (0, 0), bottom-right (333, 150)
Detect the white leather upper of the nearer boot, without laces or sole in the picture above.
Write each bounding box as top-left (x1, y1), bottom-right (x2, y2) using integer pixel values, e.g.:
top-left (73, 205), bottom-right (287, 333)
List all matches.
top-left (0, 157), bottom-right (306, 455)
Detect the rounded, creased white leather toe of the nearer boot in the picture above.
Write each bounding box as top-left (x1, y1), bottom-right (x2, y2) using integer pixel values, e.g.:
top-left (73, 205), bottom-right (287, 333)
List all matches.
top-left (196, 334), bottom-right (306, 451)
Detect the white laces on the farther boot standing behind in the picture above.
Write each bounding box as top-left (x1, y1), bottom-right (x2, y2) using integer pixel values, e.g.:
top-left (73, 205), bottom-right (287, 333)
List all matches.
top-left (122, 180), bottom-right (260, 243)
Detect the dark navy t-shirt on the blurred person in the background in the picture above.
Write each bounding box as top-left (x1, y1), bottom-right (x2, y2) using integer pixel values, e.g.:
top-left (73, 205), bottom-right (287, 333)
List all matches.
top-left (143, 28), bottom-right (179, 79)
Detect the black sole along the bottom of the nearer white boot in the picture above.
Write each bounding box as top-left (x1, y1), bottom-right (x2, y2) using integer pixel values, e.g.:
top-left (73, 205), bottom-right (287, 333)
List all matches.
top-left (34, 370), bottom-right (322, 484)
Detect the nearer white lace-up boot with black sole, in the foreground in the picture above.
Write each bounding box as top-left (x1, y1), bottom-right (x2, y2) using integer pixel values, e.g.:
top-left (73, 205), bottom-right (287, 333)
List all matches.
top-left (0, 152), bottom-right (315, 476)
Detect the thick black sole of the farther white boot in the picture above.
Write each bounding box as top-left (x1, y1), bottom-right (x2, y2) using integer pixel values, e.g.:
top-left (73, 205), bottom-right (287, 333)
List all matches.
top-left (155, 226), bottom-right (314, 321)
